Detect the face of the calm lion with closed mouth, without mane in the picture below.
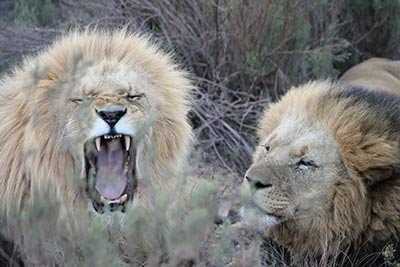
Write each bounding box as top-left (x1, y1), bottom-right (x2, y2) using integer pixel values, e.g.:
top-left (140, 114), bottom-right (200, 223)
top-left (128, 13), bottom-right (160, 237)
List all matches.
top-left (244, 114), bottom-right (344, 227)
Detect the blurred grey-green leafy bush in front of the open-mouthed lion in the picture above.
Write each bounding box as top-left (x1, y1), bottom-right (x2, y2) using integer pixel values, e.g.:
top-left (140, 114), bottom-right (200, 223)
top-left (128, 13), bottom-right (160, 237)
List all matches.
top-left (3, 177), bottom-right (238, 266)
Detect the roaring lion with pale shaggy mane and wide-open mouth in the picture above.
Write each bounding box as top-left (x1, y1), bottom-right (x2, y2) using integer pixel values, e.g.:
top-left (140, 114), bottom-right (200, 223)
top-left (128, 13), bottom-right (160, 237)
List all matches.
top-left (0, 30), bottom-right (193, 224)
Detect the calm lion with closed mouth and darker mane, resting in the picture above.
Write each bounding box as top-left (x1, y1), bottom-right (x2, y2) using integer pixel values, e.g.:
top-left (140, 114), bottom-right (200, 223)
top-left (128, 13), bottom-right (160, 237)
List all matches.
top-left (242, 60), bottom-right (400, 261)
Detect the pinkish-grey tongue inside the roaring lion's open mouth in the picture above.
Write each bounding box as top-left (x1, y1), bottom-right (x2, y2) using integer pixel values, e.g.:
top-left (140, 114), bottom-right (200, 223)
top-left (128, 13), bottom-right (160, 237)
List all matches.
top-left (96, 139), bottom-right (127, 199)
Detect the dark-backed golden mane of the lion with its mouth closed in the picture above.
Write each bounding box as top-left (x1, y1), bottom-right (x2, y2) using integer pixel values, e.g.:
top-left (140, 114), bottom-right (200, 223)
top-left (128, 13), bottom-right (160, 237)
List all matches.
top-left (253, 78), bottom-right (400, 260)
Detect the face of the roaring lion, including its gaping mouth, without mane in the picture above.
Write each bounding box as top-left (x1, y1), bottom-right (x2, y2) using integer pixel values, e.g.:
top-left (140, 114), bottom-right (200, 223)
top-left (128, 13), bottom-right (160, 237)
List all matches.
top-left (65, 65), bottom-right (156, 214)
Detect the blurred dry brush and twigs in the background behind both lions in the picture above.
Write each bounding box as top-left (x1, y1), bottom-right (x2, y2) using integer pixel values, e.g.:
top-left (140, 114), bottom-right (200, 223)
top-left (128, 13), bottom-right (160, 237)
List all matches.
top-left (0, 0), bottom-right (400, 176)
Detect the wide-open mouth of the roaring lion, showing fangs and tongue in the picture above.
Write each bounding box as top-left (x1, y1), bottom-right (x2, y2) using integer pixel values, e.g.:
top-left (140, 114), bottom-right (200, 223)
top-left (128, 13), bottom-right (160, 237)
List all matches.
top-left (84, 134), bottom-right (136, 213)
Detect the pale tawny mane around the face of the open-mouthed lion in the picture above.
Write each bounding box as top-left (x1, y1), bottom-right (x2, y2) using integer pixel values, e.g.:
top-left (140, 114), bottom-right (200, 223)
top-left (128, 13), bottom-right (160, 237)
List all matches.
top-left (0, 30), bottom-right (193, 240)
